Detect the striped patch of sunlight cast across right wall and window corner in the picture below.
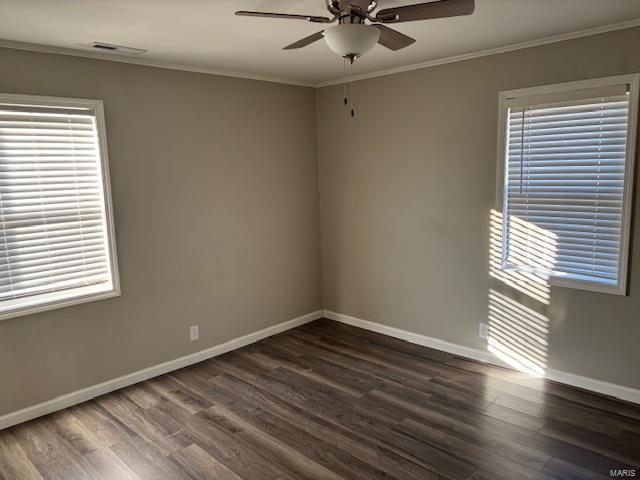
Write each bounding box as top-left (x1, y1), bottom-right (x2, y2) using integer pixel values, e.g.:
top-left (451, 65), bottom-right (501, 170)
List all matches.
top-left (487, 210), bottom-right (556, 376)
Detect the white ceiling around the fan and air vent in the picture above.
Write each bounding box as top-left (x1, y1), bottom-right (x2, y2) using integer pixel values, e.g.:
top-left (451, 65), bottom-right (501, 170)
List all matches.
top-left (0, 0), bottom-right (640, 84)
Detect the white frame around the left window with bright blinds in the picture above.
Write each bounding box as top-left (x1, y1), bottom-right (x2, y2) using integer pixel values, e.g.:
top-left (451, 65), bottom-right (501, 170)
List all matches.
top-left (0, 93), bottom-right (122, 321)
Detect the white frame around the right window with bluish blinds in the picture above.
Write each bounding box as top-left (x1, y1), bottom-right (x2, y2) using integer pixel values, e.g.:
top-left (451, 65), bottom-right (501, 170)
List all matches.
top-left (495, 73), bottom-right (640, 295)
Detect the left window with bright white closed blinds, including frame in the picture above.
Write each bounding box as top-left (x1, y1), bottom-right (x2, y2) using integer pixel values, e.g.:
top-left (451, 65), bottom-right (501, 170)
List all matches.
top-left (0, 95), bottom-right (119, 319)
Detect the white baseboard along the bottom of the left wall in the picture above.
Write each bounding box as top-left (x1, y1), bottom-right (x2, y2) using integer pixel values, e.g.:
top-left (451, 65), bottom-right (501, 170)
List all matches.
top-left (0, 310), bottom-right (322, 430)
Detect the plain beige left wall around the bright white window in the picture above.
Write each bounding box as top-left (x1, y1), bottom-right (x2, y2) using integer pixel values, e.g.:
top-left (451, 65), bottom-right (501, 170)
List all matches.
top-left (0, 49), bottom-right (321, 415)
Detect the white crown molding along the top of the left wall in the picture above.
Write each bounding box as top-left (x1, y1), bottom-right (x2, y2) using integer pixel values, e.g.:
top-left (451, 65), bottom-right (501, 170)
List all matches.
top-left (0, 39), bottom-right (315, 88)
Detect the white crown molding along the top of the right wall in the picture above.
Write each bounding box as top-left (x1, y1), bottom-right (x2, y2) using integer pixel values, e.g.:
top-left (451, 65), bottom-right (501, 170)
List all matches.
top-left (315, 18), bottom-right (640, 88)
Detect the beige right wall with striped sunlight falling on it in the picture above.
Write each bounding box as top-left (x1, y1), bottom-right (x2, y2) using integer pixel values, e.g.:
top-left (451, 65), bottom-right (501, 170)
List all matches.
top-left (317, 28), bottom-right (640, 388)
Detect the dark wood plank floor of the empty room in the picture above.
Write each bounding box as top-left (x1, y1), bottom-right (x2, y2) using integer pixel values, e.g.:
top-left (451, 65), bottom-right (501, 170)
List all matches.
top-left (0, 320), bottom-right (640, 480)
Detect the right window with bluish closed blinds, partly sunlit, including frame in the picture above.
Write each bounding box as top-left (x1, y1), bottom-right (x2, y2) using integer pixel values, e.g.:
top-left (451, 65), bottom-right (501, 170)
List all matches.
top-left (498, 75), bottom-right (639, 295)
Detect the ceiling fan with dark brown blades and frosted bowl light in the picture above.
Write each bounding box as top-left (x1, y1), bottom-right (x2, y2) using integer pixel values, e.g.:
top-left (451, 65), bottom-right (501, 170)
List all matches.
top-left (236, 0), bottom-right (475, 63)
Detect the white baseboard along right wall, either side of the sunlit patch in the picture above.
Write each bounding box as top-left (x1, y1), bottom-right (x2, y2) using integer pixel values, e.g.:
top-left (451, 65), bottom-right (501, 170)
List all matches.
top-left (324, 310), bottom-right (640, 404)
